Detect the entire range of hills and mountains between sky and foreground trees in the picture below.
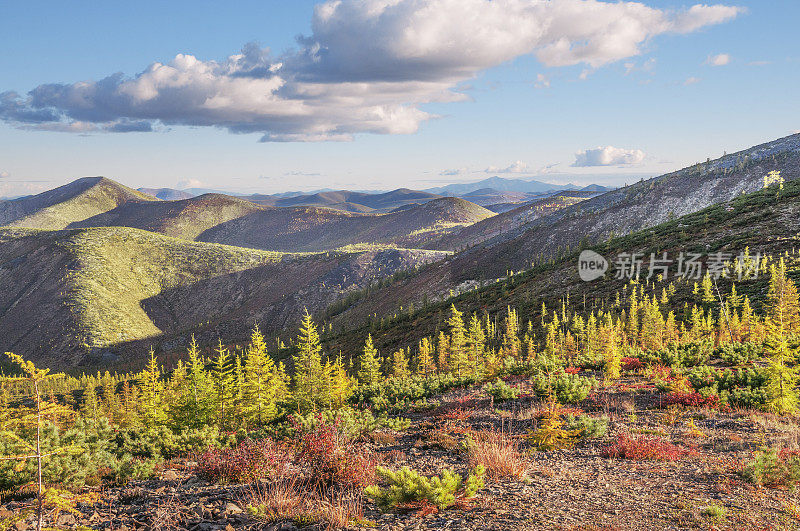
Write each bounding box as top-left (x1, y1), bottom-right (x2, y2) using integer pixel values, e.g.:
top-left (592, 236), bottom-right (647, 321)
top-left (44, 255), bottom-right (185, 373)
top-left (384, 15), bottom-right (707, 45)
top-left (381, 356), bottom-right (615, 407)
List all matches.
top-left (0, 135), bottom-right (800, 368)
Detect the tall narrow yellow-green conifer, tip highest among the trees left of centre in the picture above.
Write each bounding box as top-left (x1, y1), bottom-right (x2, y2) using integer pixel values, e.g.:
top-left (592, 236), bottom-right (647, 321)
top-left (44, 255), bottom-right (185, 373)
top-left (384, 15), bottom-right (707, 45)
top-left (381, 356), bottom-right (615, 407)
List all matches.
top-left (293, 310), bottom-right (326, 411)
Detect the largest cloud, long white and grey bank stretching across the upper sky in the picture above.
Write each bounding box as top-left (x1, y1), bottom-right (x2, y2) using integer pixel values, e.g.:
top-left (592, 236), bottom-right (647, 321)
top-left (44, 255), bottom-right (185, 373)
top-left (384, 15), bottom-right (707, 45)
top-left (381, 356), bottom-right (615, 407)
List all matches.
top-left (0, 0), bottom-right (742, 141)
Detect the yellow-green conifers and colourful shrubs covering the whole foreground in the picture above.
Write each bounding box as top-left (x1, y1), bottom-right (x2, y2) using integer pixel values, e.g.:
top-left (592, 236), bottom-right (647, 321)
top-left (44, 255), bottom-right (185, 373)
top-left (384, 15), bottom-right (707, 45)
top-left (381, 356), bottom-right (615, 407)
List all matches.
top-left (0, 176), bottom-right (800, 529)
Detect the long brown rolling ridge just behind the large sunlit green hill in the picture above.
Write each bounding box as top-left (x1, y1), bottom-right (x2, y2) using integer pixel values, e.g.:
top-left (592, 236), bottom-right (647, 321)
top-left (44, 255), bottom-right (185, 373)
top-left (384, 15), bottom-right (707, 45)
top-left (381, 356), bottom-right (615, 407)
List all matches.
top-left (65, 194), bottom-right (494, 252)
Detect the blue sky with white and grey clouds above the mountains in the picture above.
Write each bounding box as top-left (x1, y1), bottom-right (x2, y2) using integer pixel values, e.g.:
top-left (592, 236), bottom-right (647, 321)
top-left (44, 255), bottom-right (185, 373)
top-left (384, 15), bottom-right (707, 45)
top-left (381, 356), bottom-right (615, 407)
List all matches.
top-left (0, 0), bottom-right (800, 197)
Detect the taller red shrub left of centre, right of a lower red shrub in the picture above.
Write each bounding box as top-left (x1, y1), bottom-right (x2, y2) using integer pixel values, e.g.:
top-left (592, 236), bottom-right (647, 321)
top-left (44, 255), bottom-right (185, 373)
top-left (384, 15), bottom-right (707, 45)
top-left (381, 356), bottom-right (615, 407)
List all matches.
top-left (297, 420), bottom-right (376, 487)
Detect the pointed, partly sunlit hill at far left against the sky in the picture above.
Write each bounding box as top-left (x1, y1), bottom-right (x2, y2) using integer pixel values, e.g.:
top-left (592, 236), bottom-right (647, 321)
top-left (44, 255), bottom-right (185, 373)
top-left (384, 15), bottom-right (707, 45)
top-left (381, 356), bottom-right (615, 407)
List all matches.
top-left (0, 177), bottom-right (157, 230)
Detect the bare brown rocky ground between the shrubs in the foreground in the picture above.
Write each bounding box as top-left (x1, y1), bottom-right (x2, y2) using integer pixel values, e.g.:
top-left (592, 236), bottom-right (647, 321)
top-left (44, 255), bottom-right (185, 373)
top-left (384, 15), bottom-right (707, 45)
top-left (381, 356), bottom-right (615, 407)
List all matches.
top-left (0, 378), bottom-right (800, 531)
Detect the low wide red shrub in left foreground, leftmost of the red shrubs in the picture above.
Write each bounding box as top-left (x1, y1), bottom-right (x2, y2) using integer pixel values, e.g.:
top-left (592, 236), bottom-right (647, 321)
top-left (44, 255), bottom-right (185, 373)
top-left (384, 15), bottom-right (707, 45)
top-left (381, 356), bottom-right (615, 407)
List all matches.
top-left (195, 439), bottom-right (291, 483)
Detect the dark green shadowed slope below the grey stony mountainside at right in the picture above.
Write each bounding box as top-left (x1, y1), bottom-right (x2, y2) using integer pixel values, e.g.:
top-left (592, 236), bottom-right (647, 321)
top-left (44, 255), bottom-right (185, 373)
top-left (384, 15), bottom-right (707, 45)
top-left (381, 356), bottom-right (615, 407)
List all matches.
top-left (327, 175), bottom-right (800, 358)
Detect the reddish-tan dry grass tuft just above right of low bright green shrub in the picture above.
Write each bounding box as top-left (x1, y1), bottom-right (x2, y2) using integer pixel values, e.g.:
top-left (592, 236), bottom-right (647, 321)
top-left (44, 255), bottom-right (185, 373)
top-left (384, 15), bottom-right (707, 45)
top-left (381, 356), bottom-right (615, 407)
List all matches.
top-left (468, 431), bottom-right (529, 479)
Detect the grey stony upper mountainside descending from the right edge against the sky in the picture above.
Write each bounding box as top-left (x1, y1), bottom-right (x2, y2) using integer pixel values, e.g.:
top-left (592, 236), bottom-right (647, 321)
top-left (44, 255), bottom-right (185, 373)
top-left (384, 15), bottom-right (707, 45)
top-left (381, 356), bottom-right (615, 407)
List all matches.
top-left (318, 134), bottom-right (800, 338)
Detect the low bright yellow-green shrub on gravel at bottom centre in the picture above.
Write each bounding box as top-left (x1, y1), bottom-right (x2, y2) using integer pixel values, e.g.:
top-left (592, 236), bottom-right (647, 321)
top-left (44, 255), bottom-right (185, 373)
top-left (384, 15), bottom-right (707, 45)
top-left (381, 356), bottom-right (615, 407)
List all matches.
top-left (364, 465), bottom-right (486, 511)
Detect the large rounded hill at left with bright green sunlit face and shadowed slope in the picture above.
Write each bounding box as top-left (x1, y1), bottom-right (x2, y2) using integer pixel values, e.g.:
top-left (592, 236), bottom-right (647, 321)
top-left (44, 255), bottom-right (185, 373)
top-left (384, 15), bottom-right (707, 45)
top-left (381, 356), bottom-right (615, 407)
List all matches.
top-left (0, 227), bottom-right (443, 368)
